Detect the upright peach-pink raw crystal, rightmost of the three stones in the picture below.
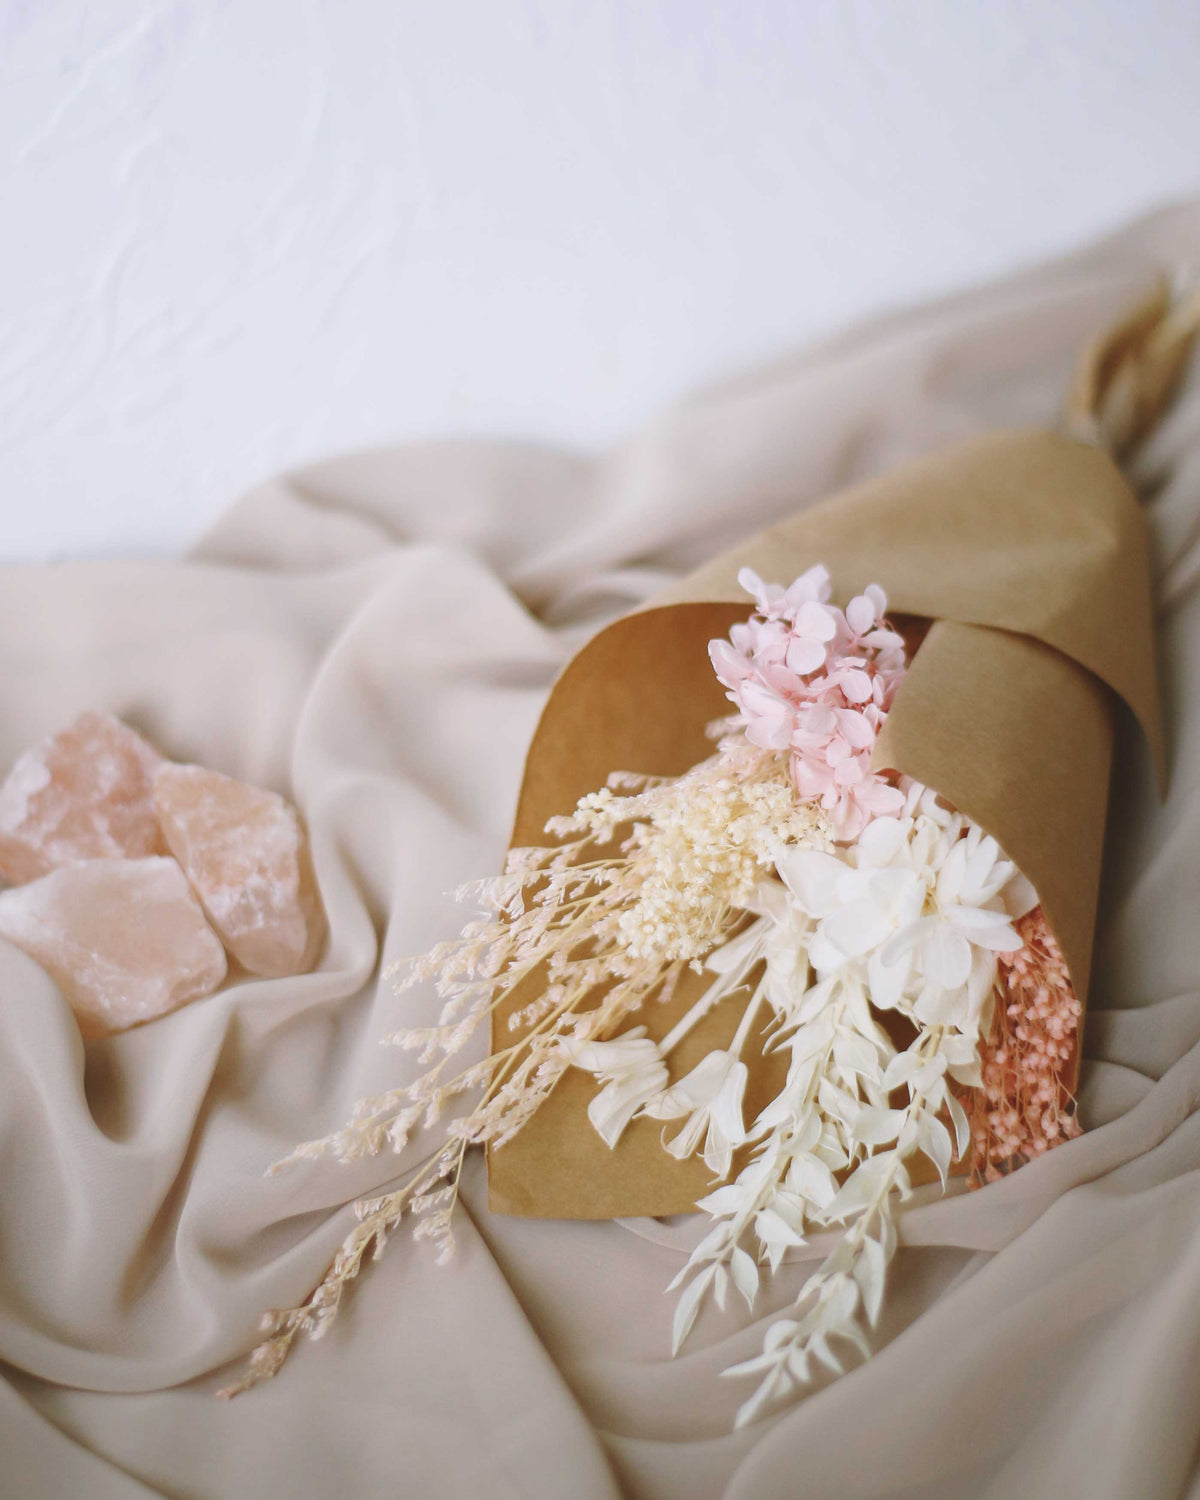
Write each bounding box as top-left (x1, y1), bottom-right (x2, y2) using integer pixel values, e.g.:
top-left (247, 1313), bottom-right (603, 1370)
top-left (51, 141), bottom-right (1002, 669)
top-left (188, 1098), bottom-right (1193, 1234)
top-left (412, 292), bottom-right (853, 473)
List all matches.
top-left (155, 764), bottom-right (326, 978)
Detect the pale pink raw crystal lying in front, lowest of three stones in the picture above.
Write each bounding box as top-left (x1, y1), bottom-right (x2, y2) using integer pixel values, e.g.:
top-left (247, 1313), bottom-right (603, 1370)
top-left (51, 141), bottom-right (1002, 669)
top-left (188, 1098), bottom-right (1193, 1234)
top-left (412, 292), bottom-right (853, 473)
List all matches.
top-left (0, 858), bottom-right (225, 1037)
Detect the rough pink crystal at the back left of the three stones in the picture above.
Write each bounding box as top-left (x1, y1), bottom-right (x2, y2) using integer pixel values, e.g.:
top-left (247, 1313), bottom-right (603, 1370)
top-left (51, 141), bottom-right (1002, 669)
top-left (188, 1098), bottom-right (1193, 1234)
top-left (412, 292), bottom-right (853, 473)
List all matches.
top-left (0, 710), bottom-right (165, 885)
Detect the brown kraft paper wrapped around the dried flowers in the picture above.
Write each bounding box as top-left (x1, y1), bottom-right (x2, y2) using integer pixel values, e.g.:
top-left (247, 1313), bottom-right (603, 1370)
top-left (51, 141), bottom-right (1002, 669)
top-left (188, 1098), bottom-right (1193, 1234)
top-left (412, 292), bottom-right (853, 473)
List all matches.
top-left (489, 429), bottom-right (1164, 1218)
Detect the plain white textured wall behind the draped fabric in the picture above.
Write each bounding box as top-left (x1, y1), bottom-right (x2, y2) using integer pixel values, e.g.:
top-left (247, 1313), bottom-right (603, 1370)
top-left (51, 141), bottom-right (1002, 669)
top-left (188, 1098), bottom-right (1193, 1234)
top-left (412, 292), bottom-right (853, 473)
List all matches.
top-left (0, 0), bottom-right (1200, 558)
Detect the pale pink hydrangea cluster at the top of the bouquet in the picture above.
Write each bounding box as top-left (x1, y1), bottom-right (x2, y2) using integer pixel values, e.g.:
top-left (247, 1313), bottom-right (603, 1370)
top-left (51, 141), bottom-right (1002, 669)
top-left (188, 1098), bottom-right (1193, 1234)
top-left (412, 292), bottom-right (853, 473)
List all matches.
top-left (708, 566), bottom-right (905, 840)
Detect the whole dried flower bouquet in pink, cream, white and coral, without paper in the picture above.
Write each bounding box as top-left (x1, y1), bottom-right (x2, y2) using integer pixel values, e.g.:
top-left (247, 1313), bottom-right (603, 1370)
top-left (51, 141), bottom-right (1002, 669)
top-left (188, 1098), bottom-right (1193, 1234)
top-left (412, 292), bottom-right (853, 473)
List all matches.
top-left (225, 567), bottom-right (1080, 1424)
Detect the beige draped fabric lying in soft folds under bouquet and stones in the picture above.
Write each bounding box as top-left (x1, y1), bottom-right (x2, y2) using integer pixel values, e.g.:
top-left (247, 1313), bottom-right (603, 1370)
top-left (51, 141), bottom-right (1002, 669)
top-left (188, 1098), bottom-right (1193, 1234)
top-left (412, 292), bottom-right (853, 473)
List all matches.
top-left (0, 204), bottom-right (1200, 1500)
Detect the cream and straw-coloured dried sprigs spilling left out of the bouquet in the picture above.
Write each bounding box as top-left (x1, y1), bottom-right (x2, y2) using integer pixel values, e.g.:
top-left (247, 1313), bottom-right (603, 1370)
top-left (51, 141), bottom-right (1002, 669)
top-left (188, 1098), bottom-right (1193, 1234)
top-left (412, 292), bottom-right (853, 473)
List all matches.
top-left (222, 737), bottom-right (830, 1395)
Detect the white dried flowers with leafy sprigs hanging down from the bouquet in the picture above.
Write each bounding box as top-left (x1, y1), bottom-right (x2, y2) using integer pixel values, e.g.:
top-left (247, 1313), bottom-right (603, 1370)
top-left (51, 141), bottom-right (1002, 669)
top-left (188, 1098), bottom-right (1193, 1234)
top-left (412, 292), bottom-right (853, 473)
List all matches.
top-left (609, 782), bottom-right (1032, 1422)
